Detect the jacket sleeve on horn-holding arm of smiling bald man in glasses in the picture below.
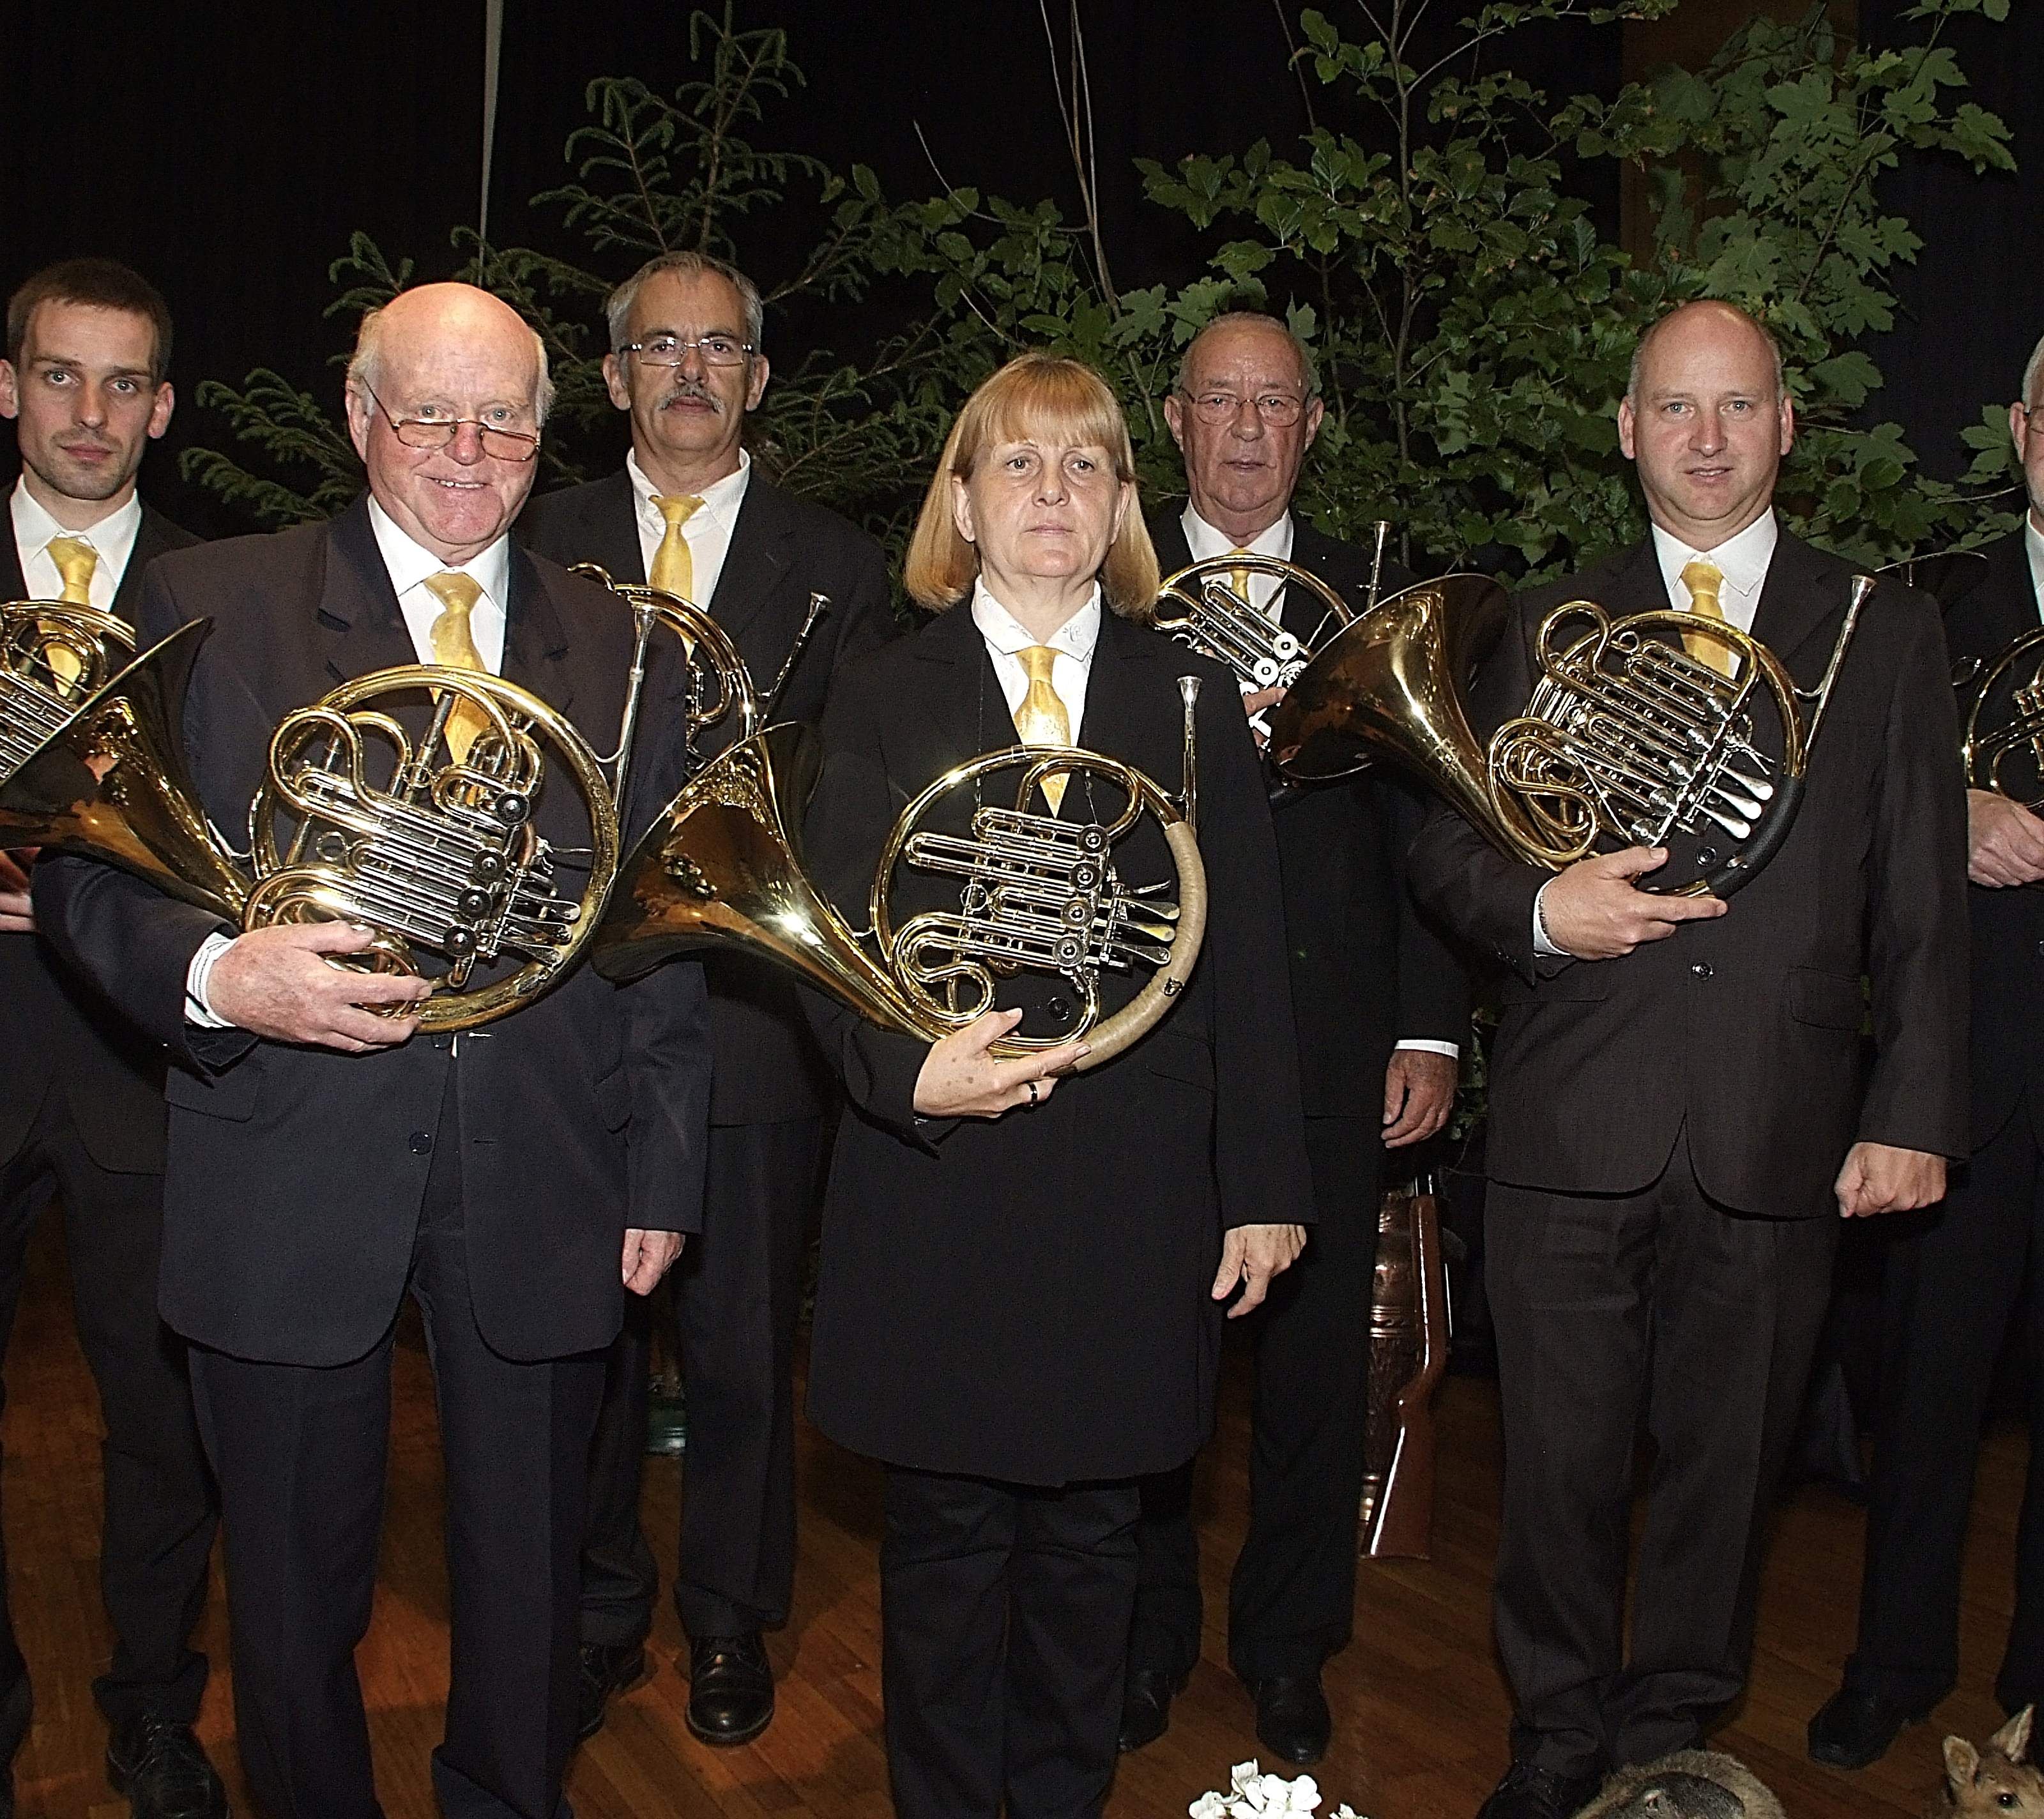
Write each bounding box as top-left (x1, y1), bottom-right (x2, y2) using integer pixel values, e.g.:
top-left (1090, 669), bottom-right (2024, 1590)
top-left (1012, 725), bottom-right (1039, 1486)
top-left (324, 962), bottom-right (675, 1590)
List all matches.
top-left (34, 564), bottom-right (256, 1073)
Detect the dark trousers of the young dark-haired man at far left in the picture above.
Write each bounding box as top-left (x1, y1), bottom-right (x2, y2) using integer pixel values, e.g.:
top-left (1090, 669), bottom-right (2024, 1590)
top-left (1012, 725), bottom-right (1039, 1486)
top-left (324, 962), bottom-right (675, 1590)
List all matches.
top-left (0, 1085), bottom-right (218, 1764)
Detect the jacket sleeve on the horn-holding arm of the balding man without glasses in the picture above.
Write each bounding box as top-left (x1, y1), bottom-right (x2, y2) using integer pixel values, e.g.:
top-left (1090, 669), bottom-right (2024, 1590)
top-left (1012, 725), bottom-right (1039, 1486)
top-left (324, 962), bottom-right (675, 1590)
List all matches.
top-left (1407, 611), bottom-right (1566, 985)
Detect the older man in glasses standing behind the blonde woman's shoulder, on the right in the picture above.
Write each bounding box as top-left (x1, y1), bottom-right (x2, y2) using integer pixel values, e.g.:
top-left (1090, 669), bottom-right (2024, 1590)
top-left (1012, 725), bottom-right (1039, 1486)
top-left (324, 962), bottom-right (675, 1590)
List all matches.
top-left (1120, 315), bottom-right (1468, 1764)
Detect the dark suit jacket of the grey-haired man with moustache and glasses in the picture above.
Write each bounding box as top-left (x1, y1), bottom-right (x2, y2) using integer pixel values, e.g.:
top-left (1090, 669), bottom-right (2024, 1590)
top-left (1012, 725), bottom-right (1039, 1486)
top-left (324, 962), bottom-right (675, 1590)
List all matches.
top-left (519, 468), bottom-right (896, 1124)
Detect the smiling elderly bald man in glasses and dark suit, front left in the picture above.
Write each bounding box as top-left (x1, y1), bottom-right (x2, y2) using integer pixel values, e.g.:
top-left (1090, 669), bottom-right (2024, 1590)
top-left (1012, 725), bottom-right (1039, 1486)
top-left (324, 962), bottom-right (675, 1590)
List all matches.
top-left (34, 284), bottom-right (709, 1819)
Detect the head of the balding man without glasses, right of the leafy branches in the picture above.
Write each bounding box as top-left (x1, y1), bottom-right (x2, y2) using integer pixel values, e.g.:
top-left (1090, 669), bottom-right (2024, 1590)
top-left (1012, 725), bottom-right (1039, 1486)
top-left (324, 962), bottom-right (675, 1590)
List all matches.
top-left (1619, 303), bottom-right (1795, 550)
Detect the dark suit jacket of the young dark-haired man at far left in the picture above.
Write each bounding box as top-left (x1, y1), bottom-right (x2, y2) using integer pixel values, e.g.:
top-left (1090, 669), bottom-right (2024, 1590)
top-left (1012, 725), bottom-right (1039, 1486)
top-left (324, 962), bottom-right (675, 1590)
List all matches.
top-left (0, 505), bottom-right (198, 1175)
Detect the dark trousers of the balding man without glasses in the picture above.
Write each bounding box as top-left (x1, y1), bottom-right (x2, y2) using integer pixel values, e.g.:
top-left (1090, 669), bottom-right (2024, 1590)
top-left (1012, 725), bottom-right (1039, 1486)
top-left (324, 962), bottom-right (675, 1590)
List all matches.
top-left (1484, 1141), bottom-right (1838, 1774)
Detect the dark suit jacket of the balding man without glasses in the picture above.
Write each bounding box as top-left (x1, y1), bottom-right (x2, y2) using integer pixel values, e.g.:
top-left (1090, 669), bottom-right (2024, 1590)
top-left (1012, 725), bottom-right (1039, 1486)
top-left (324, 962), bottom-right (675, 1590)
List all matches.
top-left (1410, 531), bottom-right (1966, 1218)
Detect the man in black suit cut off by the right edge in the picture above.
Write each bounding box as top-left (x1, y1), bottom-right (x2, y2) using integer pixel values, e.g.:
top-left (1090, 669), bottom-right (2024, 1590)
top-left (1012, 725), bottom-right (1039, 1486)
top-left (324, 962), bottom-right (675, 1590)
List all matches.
top-left (1809, 344), bottom-right (2044, 1768)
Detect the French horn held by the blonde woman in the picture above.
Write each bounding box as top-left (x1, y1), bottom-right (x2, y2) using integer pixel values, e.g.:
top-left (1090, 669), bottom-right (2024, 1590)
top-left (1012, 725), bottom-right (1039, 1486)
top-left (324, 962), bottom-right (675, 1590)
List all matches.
top-left (593, 676), bottom-right (1206, 1069)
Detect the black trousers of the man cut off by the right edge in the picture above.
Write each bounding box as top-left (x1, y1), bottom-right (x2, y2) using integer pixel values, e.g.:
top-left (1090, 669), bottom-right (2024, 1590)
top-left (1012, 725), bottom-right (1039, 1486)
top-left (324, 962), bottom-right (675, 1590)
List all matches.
top-left (1846, 1106), bottom-right (2044, 1710)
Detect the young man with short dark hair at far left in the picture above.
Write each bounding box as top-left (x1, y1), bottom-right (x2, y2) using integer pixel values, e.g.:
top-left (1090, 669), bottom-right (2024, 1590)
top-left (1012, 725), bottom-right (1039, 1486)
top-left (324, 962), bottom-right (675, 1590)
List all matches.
top-left (0, 259), bottom-right (227, 1819)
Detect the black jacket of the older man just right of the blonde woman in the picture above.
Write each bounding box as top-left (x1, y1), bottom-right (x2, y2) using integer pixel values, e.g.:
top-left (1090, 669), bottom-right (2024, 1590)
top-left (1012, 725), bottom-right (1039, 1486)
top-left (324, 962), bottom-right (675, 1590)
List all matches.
top-left (1151, 511), bottom-right (1470, 1126)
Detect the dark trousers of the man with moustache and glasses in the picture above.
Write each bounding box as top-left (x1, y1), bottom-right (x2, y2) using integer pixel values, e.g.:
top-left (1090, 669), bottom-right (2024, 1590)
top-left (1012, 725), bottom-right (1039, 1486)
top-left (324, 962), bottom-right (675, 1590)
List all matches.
top-left (583, 1118), bottom-right (824, 1645)
